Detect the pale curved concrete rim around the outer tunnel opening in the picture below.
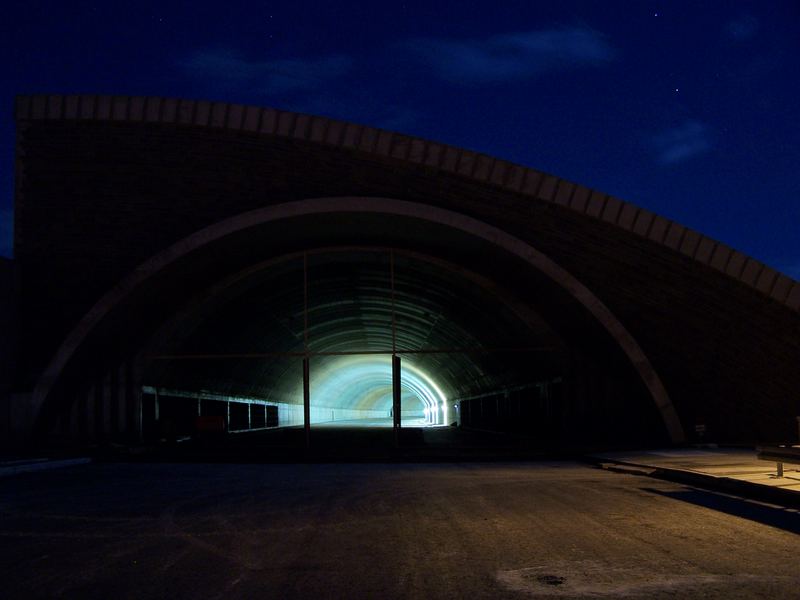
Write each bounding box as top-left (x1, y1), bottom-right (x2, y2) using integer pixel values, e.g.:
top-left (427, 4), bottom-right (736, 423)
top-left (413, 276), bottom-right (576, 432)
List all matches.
top-left (32, 197), bottom-right (686, 444)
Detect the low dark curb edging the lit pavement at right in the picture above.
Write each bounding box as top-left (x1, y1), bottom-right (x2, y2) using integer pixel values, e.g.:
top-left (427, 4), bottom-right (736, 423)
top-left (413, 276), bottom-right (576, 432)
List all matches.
top-left (586, 456), bottom-right (800, 507)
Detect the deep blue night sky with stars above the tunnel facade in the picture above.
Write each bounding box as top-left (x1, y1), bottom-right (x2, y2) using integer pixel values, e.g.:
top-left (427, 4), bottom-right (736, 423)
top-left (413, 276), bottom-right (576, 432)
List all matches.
top-left (0, 0), bottom-right (800, 278)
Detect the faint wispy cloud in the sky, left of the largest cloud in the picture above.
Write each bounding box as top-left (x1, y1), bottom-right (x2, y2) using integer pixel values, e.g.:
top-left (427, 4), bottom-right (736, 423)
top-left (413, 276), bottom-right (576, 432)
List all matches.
top-left (179, 50), bottom-right (352, 94)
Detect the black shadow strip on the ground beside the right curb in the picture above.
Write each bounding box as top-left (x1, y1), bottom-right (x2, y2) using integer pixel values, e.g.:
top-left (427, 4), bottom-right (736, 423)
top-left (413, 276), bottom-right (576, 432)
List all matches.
top-left (641, 488), bottom-right (800, 534)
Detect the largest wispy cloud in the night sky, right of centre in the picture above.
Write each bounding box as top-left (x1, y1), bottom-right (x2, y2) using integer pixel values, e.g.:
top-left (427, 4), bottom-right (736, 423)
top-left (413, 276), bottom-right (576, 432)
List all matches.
top-left (405, 27), bottom-right (616, 84)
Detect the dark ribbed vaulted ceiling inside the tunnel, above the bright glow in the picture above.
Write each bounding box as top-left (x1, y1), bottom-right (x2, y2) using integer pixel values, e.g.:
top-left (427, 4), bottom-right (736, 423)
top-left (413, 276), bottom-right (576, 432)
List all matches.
top-left (148, 249), bottom-right (567, 402)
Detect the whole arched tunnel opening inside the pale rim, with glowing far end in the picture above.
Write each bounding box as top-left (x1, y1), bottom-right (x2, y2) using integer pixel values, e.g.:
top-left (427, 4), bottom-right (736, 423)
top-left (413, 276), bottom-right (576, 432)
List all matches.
top-left (37, 199), bottom-right (681, 446)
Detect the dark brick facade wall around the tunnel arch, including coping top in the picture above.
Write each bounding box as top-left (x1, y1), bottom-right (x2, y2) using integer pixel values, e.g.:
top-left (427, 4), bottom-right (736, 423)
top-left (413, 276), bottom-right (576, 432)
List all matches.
top-left (14, 96), bottom-right (800, 441)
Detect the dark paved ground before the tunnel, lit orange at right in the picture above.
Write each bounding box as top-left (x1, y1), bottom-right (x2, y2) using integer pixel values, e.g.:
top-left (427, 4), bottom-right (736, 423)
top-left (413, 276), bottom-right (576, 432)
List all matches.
top-left (0, 463), bottom-right (800, 599)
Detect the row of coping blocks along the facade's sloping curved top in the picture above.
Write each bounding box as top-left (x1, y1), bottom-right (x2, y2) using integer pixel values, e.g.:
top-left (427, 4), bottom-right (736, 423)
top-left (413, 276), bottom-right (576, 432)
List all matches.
top-left (15, 94), bottom-right (800, 313)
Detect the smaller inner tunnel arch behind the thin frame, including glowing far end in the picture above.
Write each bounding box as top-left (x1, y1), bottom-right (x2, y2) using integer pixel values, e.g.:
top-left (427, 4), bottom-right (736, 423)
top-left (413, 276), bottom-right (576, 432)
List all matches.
top-left (144, 247), bottom-right (568, 436)
